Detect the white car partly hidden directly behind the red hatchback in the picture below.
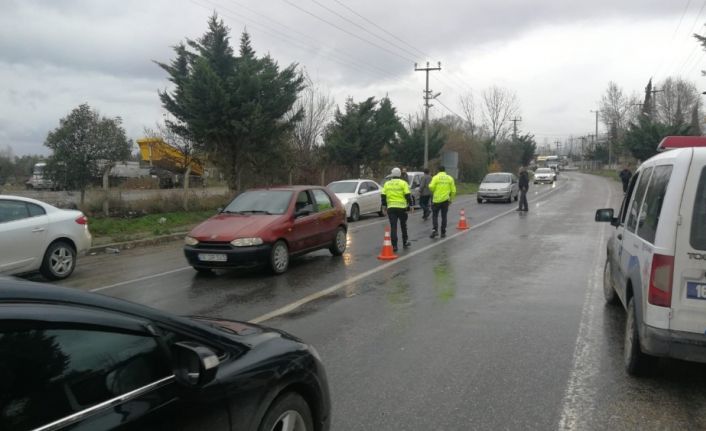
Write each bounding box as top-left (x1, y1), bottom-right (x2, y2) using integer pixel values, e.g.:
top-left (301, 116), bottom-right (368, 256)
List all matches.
top-left (328, 180), bottom-right (385, 221)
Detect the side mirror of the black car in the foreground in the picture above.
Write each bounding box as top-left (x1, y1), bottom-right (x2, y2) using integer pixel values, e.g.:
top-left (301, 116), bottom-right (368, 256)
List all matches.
top-left (172, 341), bottom-right (220, 387)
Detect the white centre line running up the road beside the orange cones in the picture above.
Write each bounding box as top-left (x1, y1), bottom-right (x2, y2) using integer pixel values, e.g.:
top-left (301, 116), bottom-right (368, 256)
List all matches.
top-left (249, 181), bottom-right (563, 323)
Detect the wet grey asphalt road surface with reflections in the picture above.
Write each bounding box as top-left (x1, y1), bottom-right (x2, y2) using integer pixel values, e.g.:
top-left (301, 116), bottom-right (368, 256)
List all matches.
top-left (57, 173), bottom-right (706, 430)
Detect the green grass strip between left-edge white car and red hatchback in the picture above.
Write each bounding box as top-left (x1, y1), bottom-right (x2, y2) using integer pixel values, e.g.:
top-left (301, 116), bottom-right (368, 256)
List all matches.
top-left (88, 211), bottom-right (216, 241)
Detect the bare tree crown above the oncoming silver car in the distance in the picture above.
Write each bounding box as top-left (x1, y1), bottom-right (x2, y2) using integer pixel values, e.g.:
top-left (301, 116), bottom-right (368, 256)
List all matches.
top-left (482, 85), bottom-right (520, 144)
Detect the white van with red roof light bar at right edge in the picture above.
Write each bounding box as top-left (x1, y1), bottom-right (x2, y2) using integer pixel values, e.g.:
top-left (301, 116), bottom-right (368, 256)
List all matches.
top-left (596, 136), bottom-right (706, 375)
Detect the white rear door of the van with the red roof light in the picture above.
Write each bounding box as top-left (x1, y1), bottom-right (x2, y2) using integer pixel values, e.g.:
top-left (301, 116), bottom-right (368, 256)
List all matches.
top-left (670, 148), bottom-right (706, 334)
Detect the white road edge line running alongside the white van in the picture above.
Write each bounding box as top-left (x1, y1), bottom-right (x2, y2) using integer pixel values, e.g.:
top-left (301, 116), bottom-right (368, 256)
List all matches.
top-left (559, 184), bottom-right (613, 430)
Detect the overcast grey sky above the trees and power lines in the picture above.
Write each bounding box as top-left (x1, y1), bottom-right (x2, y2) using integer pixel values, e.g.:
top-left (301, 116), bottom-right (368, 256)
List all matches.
top-left (0, 0), bottom-right (706, 155)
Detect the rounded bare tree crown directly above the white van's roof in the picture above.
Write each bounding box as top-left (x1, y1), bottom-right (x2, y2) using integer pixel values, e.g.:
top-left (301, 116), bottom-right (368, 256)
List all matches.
top-left (655, 77), bottom-right (701, 126)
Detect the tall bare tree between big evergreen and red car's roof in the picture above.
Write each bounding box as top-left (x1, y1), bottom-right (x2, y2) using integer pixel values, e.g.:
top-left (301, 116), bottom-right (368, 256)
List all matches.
top-left (289, 76), bottom-right (334, 184)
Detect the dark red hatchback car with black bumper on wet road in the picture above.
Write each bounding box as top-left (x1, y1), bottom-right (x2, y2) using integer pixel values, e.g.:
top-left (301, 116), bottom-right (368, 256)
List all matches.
top-left (184, 186), bottom-right (347, 274)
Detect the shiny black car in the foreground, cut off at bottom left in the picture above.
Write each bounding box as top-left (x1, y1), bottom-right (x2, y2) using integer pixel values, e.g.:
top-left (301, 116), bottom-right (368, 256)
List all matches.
top-left (0, 278), bottom-right (330, 431)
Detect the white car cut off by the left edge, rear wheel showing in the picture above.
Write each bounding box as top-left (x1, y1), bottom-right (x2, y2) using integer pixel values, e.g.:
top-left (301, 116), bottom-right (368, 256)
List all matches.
top-left (0, 195), bottom-right (91, 280)
